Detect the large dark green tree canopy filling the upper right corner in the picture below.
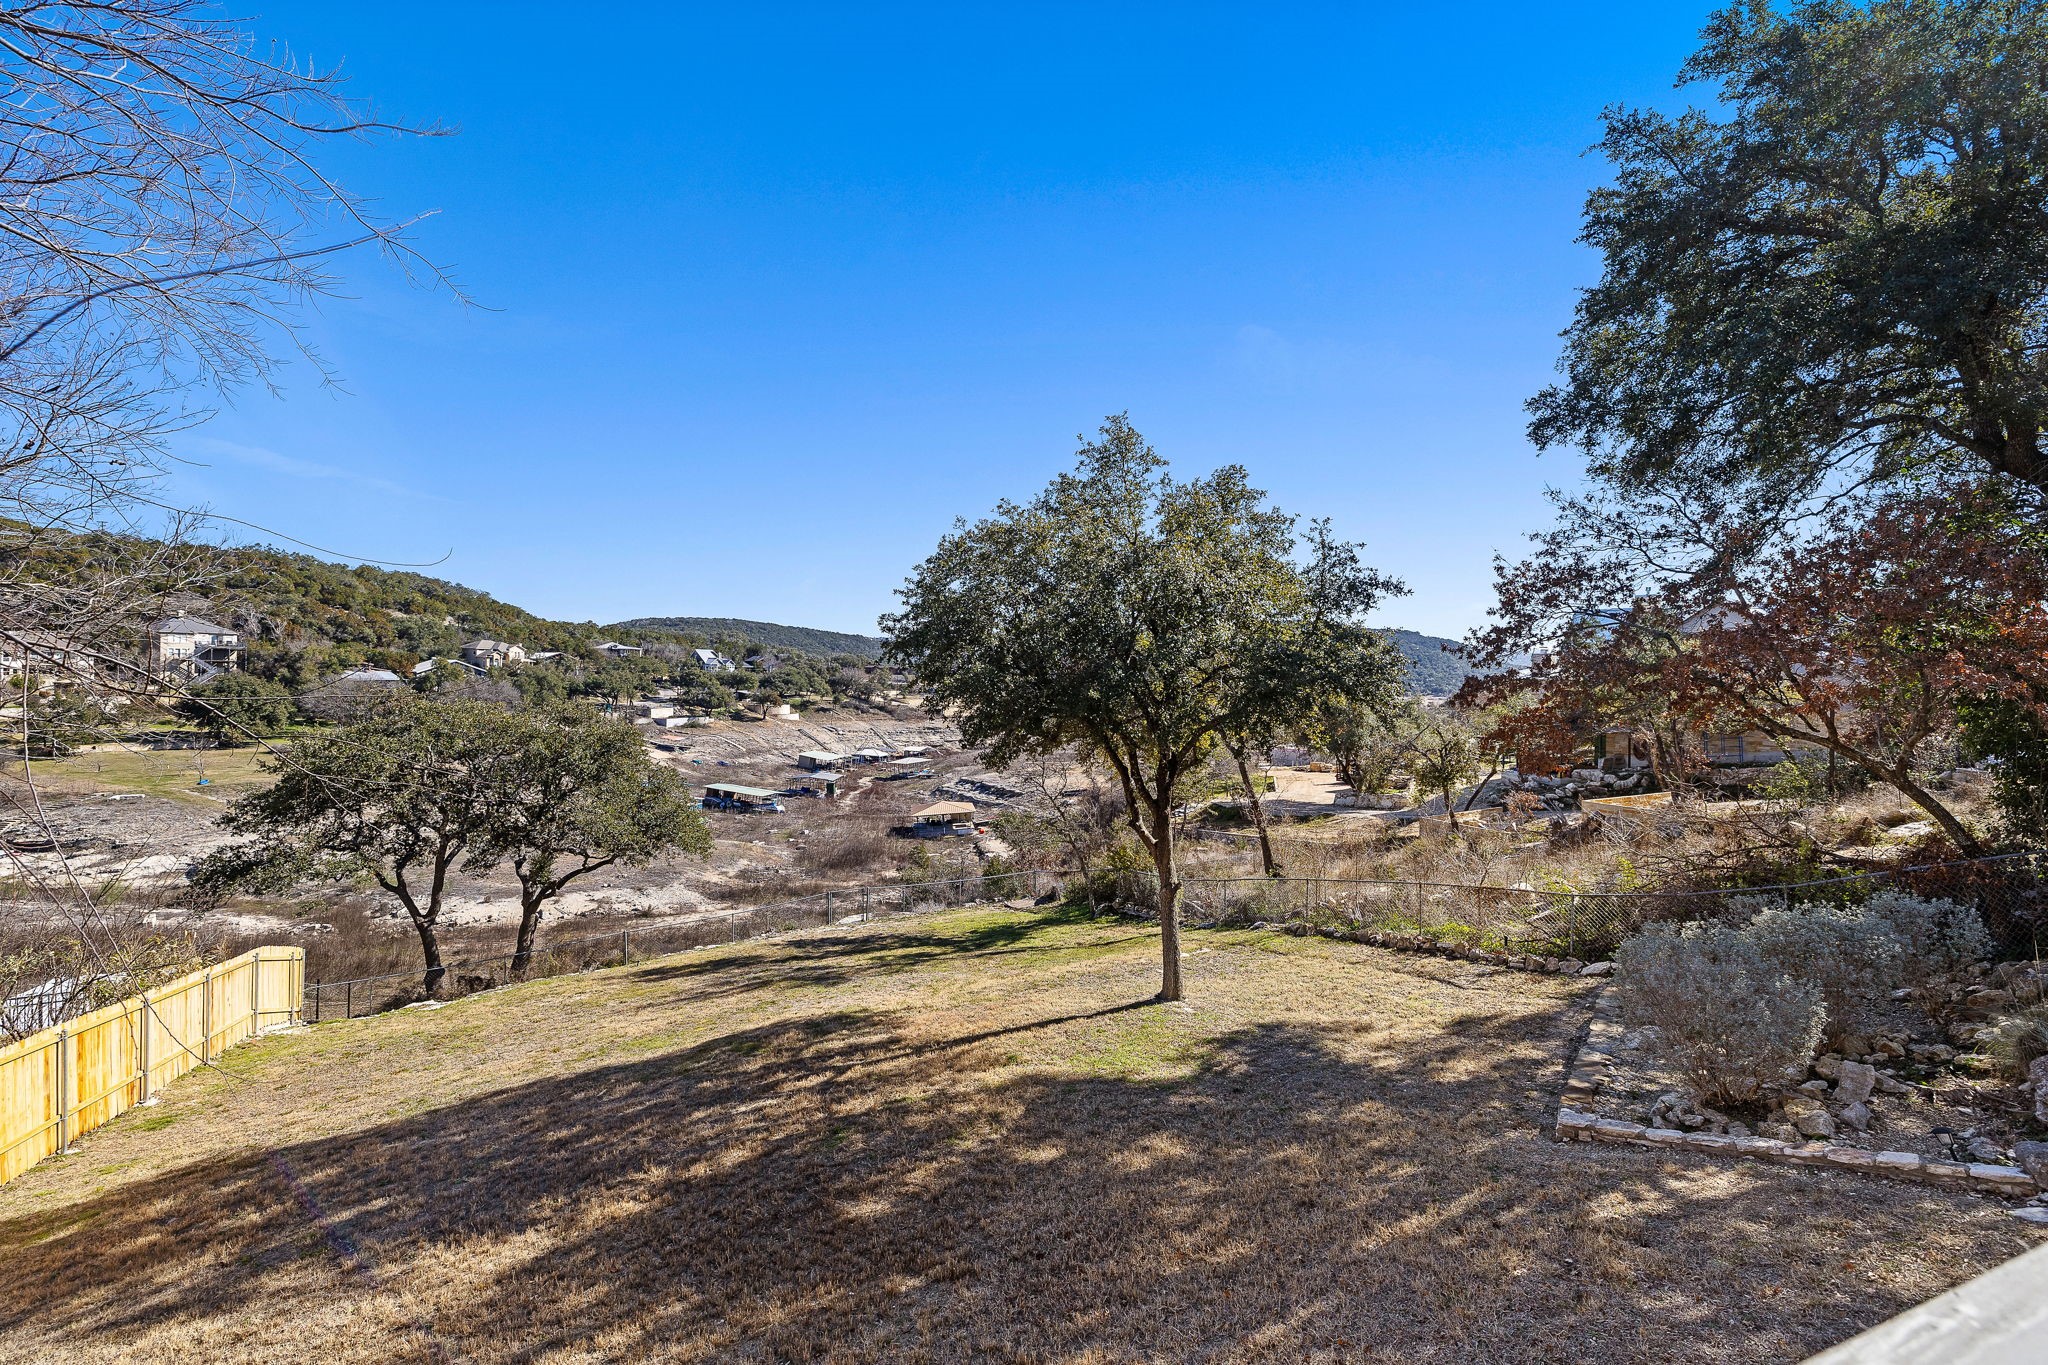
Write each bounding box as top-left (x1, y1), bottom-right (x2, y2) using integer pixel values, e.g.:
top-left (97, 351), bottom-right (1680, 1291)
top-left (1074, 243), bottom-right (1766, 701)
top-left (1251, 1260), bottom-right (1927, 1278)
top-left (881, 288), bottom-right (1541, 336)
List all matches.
top-left (1530, 0), bottom-right (2048, 518)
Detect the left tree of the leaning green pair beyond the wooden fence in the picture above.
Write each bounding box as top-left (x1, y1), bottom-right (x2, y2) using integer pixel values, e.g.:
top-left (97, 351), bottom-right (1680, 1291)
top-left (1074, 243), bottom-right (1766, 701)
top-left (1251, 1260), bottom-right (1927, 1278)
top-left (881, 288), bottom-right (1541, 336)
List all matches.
top-left (195, 698), bottom-right (528, 995)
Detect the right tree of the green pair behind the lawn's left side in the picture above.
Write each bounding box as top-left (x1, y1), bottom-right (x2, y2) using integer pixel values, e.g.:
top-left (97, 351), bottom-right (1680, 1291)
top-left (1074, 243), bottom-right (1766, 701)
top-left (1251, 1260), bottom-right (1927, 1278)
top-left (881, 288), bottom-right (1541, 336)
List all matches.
top-left (473, 706), bottom-right (711, 976)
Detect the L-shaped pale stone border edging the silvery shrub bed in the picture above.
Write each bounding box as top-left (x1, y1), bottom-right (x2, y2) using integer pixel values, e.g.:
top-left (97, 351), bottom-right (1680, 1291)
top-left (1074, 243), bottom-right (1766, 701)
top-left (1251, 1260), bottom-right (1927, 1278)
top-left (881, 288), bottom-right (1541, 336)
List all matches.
top-left (1556, 990), bottom-right (2040, 1199)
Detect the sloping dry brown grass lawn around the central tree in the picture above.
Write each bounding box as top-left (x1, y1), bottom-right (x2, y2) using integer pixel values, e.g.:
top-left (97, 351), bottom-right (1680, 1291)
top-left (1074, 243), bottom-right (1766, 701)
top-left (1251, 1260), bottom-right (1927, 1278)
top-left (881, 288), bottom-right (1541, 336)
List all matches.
top-left (0, 911), bottom-right (2028, 1363)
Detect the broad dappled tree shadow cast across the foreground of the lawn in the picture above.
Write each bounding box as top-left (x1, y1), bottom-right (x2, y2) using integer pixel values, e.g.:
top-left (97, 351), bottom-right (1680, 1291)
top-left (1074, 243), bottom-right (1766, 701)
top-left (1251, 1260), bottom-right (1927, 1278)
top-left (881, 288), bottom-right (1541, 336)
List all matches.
top-left (0, 961), bottom-right (2023, 1363)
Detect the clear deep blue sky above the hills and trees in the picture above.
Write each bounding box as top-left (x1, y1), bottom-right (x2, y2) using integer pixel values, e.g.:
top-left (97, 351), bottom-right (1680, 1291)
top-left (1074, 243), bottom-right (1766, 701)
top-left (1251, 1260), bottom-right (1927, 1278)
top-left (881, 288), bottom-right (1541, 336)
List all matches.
top-left (176, 0), bottom-right (1710, 634)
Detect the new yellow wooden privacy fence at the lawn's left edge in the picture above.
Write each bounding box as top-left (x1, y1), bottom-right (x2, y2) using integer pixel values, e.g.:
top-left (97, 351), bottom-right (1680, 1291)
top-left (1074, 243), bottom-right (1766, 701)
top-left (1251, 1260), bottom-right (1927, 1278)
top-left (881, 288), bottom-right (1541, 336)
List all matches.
top-left (0, 948), bottom-right (305, 1183)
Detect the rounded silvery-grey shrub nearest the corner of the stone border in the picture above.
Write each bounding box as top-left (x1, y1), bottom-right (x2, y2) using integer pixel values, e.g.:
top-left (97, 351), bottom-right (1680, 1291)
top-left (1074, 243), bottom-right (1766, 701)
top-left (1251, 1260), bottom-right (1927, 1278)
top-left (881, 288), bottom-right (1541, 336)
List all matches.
top-left (1616, 923), bottom-right (1827, 1105)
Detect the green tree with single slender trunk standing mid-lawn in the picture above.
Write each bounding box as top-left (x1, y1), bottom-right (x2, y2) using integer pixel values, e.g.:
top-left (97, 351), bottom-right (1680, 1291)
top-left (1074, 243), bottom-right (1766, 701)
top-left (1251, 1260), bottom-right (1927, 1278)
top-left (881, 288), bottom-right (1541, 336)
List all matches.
top-left (883, 415), bottom-right (1399, 1001)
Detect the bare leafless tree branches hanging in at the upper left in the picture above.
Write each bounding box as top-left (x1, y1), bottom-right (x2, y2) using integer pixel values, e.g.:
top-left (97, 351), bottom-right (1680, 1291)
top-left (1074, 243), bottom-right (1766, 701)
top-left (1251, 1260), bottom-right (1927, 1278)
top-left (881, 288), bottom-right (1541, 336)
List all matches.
top-left (0, 0), bottom-right (444, 1015)
